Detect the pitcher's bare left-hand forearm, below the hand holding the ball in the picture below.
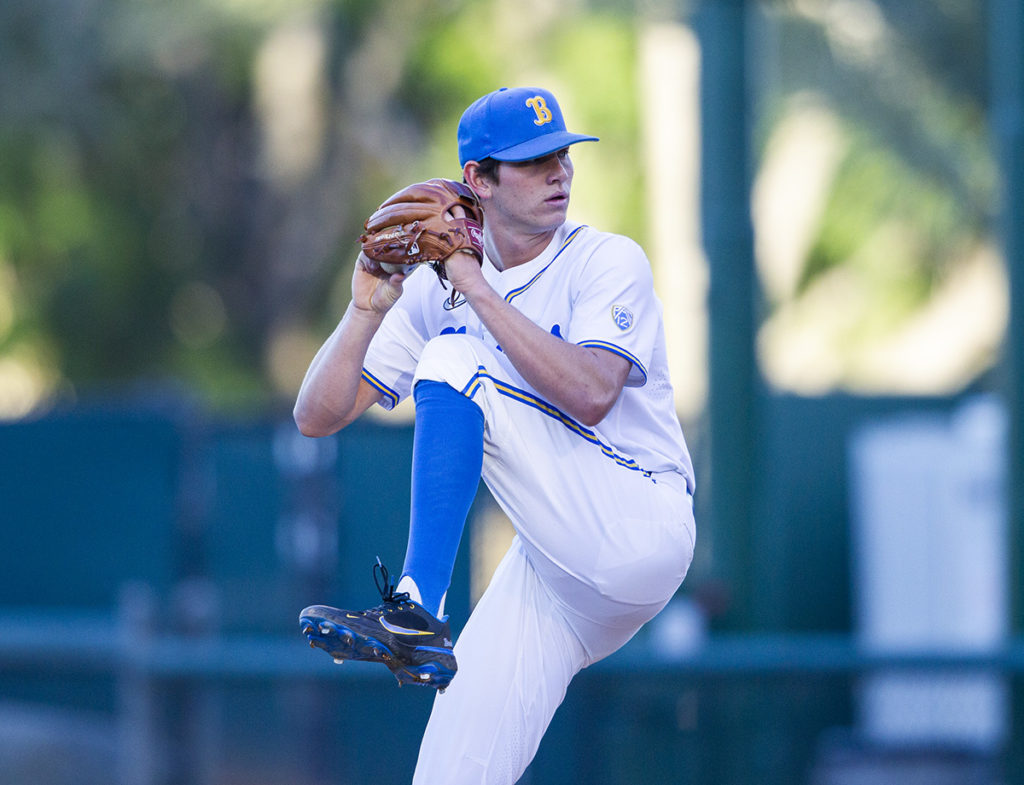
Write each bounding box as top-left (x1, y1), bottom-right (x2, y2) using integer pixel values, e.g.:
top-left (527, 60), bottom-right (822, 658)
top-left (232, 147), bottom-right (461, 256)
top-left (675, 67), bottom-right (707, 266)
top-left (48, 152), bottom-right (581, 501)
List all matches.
top-left (293, 306), bottom-right (383, 436)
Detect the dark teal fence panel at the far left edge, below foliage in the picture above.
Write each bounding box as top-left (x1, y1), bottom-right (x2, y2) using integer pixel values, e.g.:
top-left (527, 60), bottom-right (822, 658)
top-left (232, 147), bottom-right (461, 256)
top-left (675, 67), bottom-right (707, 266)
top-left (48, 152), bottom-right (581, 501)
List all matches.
top-left (0, 409), bottom-right (183, 608)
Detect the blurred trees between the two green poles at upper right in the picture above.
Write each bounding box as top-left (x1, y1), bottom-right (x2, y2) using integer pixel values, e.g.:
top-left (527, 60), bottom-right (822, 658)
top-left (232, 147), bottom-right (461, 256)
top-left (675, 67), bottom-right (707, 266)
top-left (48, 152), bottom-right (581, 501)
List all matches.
top-left (755, 0), bottom-right (1000, 393)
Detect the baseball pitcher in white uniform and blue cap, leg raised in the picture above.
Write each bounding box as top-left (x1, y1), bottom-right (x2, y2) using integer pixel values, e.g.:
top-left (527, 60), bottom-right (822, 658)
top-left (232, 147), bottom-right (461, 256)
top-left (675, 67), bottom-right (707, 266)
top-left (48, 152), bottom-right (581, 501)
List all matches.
top-left (295, 87), bottom-right (695, 785)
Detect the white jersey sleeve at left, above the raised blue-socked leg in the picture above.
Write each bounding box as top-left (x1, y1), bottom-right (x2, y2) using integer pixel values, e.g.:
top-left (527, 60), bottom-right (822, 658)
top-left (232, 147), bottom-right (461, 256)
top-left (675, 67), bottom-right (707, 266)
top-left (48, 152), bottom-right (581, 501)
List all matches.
top-left (362, 270), bottom-right (427, 409)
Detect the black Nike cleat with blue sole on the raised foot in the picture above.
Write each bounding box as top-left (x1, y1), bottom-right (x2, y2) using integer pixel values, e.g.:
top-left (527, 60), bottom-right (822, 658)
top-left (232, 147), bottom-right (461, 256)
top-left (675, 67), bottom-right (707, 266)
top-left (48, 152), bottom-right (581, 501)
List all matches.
top-left (299, 560), bottom-right (458, 692)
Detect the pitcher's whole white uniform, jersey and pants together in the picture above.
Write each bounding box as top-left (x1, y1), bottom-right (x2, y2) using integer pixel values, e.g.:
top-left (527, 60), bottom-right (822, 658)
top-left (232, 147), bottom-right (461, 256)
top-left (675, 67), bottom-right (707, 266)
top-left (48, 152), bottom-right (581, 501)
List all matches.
top-left (362, 216), bottom-right (695, 785)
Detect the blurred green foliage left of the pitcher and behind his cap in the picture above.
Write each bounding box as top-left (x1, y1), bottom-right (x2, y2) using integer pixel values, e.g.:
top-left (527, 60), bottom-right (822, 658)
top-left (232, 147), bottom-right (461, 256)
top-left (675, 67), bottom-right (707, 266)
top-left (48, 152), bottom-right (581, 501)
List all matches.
top-left (0, 0), bottom-right (641, 416)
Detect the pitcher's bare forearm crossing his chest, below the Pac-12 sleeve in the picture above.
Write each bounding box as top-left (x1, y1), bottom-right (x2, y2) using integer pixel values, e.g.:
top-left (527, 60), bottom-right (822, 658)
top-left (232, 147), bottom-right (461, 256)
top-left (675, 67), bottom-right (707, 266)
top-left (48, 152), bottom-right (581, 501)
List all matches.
top-left (467, 290), bottom-right (629, 426)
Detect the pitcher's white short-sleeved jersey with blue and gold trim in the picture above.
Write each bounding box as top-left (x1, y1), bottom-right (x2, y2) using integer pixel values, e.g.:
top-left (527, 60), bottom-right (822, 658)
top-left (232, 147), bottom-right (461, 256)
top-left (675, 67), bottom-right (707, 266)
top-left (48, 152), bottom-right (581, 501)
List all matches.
top-left (364, 217), bottom-right (693, 492)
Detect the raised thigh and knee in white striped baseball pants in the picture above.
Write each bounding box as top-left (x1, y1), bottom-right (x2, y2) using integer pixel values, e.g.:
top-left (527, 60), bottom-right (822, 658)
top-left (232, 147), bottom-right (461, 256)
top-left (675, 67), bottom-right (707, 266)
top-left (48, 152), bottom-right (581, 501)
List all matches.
top-left (417, 335), bottom-right (693, 626)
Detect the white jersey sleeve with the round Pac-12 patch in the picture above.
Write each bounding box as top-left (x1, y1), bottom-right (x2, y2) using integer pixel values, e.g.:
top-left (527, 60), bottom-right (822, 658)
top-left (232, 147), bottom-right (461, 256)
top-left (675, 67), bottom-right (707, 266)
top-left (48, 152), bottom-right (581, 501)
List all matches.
top-left (566, 236), bottom-right (662, 387)
